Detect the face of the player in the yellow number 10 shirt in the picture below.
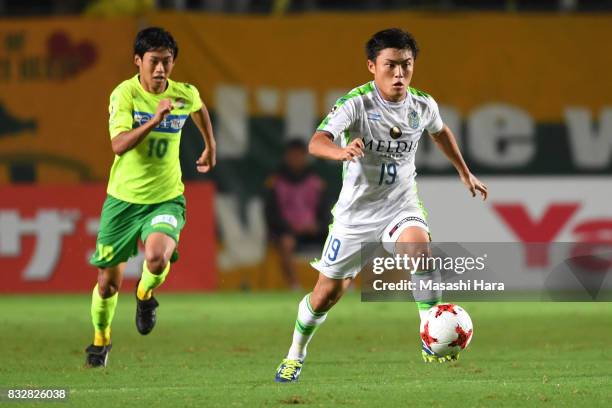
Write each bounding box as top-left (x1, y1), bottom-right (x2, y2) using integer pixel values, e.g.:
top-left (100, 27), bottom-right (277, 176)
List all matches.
top-left (134, 48), bottom-right (174, 93)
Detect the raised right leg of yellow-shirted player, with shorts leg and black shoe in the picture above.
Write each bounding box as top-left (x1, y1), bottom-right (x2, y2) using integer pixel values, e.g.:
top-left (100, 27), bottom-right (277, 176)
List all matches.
top-left (136, 196), bottom-right (185, 335)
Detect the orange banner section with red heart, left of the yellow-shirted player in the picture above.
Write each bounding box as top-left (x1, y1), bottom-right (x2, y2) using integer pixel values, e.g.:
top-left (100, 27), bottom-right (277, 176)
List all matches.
top-left (0, 18), bottom-right (136, 183)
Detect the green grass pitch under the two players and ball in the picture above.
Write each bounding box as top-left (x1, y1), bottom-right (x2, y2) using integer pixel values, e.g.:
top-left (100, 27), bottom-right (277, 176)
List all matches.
top-left (0, 294), bottom-right (612, 408)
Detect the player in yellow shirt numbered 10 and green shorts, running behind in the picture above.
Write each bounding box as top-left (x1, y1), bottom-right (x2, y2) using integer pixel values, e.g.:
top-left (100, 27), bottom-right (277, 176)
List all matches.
top-left (85, 27), bottom-right (216, 367)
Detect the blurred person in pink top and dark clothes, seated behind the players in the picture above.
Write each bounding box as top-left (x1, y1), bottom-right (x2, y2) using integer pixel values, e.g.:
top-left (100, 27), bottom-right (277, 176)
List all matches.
top-left (265, 139), bottom-right (329, 289)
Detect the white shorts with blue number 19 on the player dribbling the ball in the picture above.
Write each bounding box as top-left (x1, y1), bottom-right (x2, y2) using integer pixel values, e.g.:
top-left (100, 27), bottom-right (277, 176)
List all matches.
top-left (310, 205), bottom-right (429, 279)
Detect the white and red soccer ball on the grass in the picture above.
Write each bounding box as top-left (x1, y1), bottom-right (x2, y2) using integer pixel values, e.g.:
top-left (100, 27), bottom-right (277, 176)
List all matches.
top-left (421, 303), bottom-right (474, 356)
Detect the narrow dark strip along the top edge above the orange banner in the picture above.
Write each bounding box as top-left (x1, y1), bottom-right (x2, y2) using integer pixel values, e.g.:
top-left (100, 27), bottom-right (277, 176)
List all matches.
top-left (0, 0), bottom-right (612, 17)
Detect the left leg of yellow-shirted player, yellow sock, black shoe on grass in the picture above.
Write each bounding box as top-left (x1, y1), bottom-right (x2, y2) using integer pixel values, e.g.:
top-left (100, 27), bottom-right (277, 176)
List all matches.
top-left (86, 263), bottom-right (125, 367)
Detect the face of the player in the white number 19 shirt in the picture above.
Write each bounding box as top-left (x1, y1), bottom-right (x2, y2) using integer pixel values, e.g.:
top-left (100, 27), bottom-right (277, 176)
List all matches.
top-left (368, 48), bottom-right (414, 102)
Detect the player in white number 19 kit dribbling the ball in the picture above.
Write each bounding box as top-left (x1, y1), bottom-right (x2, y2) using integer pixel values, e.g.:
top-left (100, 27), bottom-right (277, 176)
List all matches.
top-left (275, 28), bottom-right (487, 382)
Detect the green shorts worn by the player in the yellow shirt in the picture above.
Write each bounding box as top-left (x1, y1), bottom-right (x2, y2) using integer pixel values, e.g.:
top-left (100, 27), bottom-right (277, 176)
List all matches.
top-left (89, 195), bottom-right (185, 268)
